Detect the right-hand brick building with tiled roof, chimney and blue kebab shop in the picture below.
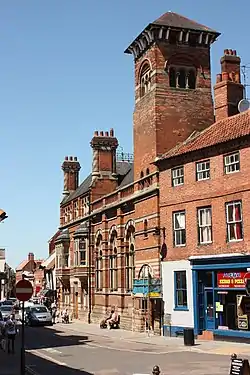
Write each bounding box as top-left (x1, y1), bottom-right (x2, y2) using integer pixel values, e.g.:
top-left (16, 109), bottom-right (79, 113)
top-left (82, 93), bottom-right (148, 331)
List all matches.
top-left (156, 50), bottom-right (250, 339)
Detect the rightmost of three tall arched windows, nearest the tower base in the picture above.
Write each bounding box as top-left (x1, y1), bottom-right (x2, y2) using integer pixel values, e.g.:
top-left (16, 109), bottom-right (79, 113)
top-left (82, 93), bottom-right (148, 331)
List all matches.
top-left (125, 226), bottom-right (135, 292)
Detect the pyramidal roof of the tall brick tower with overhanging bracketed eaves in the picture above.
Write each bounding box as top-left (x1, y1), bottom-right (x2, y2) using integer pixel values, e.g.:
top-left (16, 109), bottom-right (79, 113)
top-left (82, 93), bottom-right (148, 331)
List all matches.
top-left (125, 12), bottom-right (220, 59)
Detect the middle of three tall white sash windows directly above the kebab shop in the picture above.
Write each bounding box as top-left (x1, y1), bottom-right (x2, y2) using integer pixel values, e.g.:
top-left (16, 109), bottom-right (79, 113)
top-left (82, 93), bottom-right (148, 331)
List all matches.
top-left (198, 207), bottom-right (212, 245)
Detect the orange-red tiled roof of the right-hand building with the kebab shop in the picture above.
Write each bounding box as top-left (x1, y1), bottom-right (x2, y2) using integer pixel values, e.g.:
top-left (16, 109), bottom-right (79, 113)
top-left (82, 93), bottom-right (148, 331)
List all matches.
top-left (160, 110), bottom-right (250, 160)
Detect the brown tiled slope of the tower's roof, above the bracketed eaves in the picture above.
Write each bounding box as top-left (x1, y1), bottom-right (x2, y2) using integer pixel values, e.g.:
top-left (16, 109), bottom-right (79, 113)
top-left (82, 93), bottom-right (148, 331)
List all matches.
top-left (152, 12), bottom-right (218, 34)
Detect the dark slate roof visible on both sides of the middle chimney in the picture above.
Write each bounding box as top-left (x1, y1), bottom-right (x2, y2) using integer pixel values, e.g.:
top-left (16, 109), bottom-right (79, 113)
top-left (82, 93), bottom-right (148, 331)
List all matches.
top-left (61, 161), bottom-right (134, 204)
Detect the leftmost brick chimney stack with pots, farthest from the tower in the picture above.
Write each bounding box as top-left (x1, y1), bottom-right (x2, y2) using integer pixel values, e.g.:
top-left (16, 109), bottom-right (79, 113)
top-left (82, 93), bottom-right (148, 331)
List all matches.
top-left (62, 156), bottom-right (81, 195)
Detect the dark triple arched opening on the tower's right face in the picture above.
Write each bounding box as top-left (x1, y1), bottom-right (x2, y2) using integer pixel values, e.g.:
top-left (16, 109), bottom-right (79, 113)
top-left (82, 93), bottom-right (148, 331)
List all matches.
top-left (169, 66), bottom-right (196, 90)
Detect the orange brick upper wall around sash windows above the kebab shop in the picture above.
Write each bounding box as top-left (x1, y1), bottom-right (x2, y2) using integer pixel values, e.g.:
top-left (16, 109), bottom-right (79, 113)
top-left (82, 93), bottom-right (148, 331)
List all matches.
top-left (160, 146), bottom-right (250, 260)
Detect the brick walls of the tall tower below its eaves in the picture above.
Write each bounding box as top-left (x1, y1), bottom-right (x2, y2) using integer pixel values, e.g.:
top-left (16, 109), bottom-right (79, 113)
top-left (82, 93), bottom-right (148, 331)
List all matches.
top-left (134, 43), bottom-right (214, 178)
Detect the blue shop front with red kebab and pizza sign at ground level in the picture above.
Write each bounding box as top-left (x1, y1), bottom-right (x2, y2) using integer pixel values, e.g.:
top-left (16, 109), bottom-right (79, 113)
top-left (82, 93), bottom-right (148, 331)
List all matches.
top-left (190, 254), bottom-right (250, 339)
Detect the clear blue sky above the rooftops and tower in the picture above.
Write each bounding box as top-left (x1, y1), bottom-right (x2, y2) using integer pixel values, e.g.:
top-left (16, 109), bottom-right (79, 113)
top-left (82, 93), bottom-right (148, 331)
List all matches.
top-left (0, 0), bottom-right (250, 267)
